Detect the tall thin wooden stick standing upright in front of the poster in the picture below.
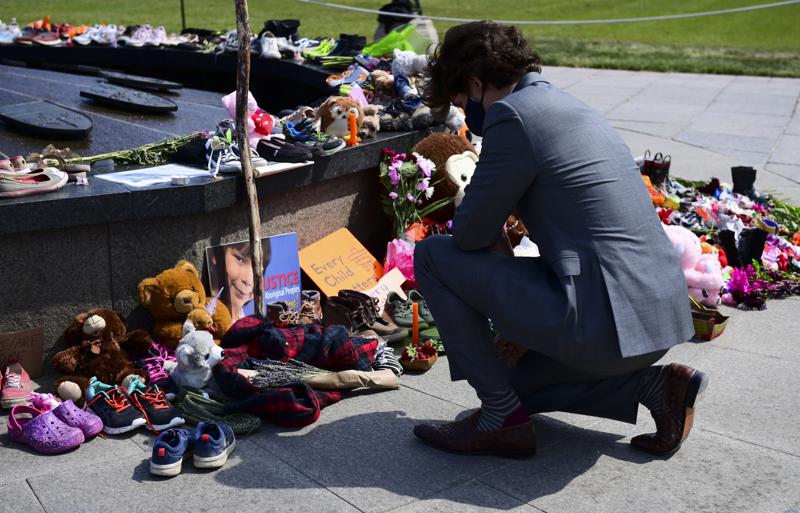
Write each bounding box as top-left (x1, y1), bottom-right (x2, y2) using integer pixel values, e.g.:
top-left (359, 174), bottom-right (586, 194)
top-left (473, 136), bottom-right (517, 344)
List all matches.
top-left (235, 0), bottom-right (264, 319)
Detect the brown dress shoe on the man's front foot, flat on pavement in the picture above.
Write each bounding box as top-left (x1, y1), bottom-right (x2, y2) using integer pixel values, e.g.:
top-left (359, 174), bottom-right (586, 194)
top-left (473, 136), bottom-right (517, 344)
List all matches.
top-left (414, 409), bottom-right (536, 458)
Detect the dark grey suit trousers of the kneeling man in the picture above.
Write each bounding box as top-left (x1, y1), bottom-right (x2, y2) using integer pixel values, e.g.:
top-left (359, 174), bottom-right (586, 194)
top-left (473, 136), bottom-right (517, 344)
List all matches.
top-left (414, 236), bottom-right (666, 423)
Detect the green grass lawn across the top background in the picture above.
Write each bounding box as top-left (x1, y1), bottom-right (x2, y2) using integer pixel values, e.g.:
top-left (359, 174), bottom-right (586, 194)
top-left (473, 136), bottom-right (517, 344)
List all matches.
top-left (0, 0), bottom-right (800, 77)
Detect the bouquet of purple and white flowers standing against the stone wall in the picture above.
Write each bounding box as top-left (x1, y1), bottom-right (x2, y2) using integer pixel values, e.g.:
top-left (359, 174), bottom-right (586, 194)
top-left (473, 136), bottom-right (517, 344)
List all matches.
top-left (380, 150), bottom-right (452, 242)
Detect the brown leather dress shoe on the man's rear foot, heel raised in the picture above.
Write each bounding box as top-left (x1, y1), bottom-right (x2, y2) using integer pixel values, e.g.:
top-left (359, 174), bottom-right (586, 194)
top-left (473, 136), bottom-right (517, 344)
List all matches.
top-left (631, 363), bottom-right (708, 454)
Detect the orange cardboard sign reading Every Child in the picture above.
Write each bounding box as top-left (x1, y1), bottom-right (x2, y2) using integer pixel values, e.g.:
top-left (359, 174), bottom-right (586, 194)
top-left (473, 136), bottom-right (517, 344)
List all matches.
top-left (300, 228), bottom-right (383, 297)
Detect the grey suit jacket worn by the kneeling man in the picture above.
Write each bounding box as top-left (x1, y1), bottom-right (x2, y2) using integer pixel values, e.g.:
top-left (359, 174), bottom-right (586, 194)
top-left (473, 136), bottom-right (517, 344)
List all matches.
top-left (453, 73), bottom-right (693, 357)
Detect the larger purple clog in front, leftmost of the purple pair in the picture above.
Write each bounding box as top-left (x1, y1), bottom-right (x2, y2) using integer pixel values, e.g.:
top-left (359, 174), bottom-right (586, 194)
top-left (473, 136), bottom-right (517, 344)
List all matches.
top-left (8, 405), bottom-right (85, 454)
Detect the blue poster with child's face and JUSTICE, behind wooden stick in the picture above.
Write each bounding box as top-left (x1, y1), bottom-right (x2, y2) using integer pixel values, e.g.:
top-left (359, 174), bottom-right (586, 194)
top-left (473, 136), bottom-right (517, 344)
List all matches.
top-left (206, 232), bottom-right (301, 322)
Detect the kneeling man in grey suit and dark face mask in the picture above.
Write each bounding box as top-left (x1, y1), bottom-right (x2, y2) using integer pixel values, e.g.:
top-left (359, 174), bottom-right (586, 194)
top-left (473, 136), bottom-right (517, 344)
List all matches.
top-left (414, 22), bottom-right (707, 456)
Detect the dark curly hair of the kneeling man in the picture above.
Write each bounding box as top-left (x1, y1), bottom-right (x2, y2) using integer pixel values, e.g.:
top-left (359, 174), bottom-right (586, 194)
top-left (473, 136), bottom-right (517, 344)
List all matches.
top-left (423, 21), bottom-right (542, 109)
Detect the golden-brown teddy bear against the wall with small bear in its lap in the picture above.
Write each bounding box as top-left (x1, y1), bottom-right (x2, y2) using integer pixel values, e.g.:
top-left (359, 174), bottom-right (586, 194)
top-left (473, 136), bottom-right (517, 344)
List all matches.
top-left (139, 260), bottom-right (232, 349)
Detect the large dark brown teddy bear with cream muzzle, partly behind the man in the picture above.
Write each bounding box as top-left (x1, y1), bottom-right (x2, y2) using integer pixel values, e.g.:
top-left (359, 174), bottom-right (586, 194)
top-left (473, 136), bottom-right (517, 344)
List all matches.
top-left (414, 132), bottom-right (528, 238)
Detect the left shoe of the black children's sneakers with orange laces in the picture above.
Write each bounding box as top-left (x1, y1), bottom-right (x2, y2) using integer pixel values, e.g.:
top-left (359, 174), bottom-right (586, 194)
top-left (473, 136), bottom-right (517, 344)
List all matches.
top-left (86, 377), bottom-right (147, 435)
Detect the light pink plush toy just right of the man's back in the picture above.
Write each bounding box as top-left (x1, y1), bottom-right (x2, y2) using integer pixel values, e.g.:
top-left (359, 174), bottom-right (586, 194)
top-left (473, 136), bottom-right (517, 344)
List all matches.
top-left (662, 225), bottom-right (724, 306)
